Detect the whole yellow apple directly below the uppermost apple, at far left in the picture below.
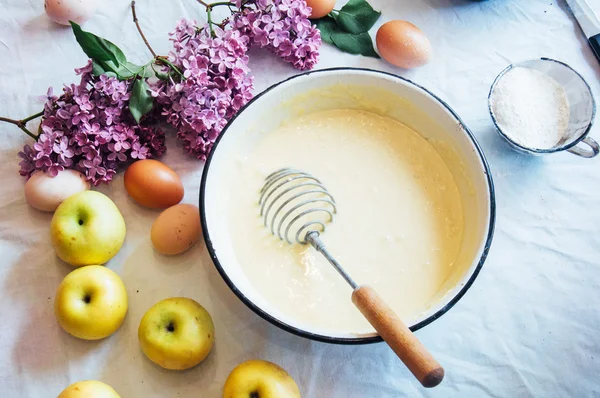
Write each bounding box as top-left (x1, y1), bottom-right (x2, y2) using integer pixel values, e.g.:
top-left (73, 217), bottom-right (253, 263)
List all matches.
top-left (54, 265), bottom-right (127, 340)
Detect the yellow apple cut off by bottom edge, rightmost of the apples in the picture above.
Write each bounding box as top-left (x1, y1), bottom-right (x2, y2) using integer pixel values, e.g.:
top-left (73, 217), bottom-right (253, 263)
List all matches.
top-left (223, 360), bottom-right (300, 398)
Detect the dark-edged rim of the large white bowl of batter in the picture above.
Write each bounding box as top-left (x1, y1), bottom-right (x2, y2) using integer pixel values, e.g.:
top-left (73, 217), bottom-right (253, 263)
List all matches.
top-left (199, 67), bottom-right (496, 345)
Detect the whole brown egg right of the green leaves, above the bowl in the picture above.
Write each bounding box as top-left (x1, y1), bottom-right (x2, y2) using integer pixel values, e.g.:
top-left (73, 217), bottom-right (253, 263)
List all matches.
top-left (375, 20), bottom-right (432, 69)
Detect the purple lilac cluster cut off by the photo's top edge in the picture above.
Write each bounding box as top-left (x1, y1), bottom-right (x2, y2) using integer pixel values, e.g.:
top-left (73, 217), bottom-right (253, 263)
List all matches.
top-left (233, 0), bottom-right (321, 70)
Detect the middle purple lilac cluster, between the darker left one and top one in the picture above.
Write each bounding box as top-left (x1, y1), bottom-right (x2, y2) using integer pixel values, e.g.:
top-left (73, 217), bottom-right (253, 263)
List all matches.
top-left (152, 20), bottom-right (253, 160)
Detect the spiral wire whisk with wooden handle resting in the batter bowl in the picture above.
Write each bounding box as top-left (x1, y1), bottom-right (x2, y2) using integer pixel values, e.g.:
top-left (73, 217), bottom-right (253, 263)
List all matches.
top-left (258, 168), bottom-right (444, 387)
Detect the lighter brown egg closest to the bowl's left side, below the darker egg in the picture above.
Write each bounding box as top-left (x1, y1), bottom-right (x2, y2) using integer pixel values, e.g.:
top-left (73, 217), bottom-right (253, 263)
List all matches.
top-left (150, 204), bottom-right (202, 254)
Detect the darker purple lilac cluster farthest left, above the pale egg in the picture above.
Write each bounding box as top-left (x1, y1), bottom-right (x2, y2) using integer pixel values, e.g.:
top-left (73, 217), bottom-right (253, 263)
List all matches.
top-left (19, 61), bottom-right (166, 185)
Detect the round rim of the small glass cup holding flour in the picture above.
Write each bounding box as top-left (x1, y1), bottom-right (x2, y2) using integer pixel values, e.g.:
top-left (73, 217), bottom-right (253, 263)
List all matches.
top-left (488, 57), bottom-right (596, 154)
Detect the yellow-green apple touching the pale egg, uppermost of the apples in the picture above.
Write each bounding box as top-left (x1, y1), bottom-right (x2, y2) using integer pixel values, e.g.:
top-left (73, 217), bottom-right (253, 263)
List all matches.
top-left (50, 191), bottom-right (125, 267)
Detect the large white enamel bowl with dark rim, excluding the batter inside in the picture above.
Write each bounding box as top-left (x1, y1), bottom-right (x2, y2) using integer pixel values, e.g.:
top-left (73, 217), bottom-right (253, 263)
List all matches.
top-left (200, 68), bottom-right (495, 344)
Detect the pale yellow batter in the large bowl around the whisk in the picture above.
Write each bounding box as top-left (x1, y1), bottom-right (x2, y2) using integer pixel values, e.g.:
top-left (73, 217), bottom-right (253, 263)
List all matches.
top-left (228, 109), bottom-right (463, 333)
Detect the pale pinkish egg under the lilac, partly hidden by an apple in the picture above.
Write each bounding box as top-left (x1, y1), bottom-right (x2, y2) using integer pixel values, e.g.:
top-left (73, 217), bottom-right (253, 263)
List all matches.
top-left (25, 170), bottom-right (90, 211)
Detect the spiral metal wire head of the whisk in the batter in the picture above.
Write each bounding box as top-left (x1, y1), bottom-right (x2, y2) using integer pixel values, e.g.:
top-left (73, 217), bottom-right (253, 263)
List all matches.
top-left (258, 168), bottom-right (337, 244)
